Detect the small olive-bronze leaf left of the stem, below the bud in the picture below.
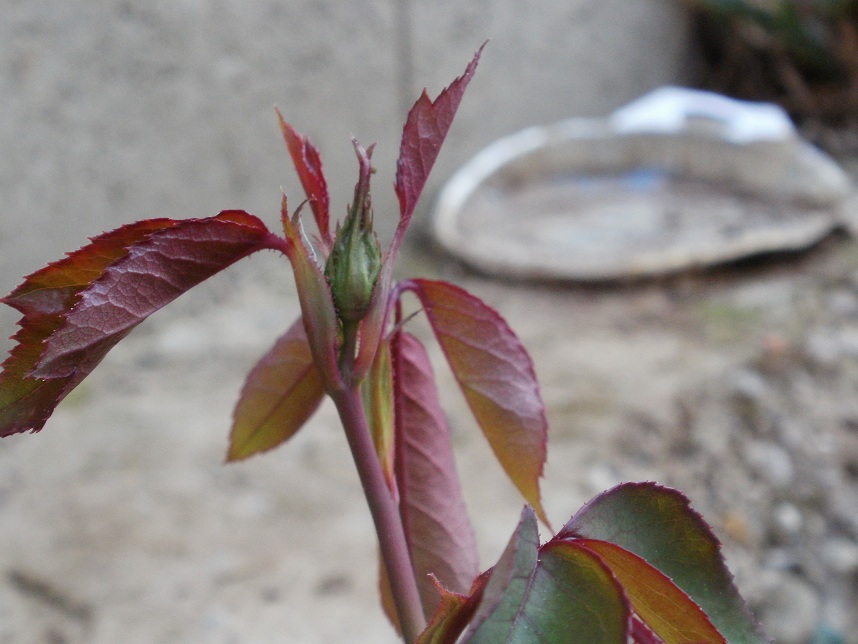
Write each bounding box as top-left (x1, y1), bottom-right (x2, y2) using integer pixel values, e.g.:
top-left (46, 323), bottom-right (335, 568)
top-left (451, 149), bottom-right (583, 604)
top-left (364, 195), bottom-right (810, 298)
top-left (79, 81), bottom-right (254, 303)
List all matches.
top-left (227, 319), bottom-right (325, 461)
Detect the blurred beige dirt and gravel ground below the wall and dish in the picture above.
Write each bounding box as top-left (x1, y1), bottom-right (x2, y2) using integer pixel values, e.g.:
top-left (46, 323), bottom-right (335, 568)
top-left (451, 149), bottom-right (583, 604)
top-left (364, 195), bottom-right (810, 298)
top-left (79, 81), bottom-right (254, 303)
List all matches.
top-left (0, 167), bottom-right (858, 644)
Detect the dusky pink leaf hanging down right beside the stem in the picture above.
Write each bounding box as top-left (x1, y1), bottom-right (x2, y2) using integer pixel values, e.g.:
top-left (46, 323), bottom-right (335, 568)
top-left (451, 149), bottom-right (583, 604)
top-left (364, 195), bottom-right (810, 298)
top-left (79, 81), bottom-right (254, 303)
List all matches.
top-left (394, 332), bottom-right (478, 616)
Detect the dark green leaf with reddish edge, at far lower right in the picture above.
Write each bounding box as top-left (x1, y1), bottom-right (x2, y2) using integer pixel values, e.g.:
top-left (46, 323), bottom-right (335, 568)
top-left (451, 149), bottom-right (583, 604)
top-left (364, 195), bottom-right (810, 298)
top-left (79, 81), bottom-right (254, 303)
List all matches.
top-left (557, 483), bottom-right (768, 644)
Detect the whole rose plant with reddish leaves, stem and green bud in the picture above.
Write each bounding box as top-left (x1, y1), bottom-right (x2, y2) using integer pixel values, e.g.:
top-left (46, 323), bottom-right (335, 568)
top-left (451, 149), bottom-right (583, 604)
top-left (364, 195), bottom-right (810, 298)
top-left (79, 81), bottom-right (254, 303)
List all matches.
top-left (0, 50), bottom-right (766, 644)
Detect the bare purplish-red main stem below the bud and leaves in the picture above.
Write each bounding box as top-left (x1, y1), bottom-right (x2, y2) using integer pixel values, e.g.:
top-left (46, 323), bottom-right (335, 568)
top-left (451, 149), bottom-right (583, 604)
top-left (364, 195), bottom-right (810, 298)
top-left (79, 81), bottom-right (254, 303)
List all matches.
top-left (331, 384), bottom-right (426, 642)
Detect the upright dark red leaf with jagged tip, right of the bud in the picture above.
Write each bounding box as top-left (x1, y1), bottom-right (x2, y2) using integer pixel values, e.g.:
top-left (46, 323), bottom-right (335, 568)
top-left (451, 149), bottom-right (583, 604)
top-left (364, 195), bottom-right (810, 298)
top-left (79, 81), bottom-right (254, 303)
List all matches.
top-left (396, 44), bottom-right (485, 222)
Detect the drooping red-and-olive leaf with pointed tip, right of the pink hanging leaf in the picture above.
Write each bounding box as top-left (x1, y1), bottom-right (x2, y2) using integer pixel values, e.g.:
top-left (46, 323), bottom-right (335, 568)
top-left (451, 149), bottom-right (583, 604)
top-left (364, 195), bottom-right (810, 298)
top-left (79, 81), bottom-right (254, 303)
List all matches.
top-left (400, 279), bottom-right (548, 525)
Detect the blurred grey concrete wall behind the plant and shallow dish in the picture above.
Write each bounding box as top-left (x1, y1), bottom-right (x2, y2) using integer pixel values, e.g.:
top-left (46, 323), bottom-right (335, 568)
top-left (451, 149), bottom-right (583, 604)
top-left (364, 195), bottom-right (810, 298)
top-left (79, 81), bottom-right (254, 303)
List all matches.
top-left (0, 0), bottom-right (688, 335)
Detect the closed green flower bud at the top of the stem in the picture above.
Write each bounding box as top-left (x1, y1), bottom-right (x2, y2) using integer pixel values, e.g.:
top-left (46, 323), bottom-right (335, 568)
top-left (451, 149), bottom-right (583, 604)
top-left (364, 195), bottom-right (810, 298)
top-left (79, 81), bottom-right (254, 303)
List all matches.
top-left (325, 146), bottom-right (381, 322)
